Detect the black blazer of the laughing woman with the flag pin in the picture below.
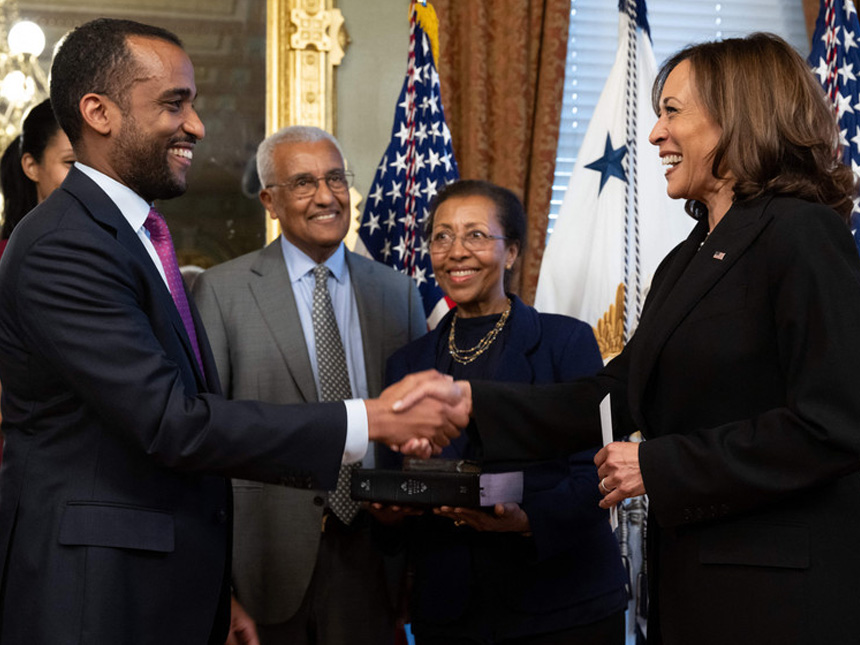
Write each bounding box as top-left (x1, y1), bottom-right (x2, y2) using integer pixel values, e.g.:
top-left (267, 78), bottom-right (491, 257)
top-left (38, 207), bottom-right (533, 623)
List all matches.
top-left (466, 197), bottom-right (860, 645)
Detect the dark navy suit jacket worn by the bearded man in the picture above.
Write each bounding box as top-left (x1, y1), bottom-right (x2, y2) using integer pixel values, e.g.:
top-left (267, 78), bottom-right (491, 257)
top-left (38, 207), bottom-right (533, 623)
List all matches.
top-left (0, 168), bottom-right (345, 645)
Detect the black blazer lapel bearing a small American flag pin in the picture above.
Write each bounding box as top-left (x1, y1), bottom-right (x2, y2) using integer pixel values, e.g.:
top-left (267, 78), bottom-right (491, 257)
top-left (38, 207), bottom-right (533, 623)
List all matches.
top-left (629, 198), bottom-right (773, 422)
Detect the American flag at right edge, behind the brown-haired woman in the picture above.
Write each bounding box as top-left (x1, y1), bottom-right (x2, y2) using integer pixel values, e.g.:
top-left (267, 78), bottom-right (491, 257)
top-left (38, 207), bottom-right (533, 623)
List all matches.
top-left (808, 0), bottom-right (860, 250)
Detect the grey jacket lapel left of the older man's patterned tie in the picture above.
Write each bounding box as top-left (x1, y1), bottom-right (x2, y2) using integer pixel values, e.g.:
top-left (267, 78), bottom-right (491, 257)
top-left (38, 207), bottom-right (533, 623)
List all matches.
top-left (248, 238), bottom-right (319, 401)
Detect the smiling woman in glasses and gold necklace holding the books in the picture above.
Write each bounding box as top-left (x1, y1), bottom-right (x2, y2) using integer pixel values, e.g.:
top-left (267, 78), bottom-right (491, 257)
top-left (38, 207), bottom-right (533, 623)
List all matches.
top-left (386, 181), bottom-right (627, 645)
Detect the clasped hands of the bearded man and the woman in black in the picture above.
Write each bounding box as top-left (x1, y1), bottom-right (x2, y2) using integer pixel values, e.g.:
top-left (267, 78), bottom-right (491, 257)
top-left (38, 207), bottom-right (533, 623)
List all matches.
top-left (364, 370), bottom-right (472, 458)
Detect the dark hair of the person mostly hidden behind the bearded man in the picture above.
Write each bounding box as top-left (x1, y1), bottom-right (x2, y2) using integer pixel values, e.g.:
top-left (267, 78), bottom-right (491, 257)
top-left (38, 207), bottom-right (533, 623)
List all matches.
top-left (0, 99), bottom-right (60, 240)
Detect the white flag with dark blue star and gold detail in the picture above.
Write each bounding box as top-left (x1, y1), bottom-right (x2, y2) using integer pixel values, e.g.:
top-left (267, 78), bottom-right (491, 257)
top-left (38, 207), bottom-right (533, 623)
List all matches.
top-left (535, 0), bottom-right (693, 358)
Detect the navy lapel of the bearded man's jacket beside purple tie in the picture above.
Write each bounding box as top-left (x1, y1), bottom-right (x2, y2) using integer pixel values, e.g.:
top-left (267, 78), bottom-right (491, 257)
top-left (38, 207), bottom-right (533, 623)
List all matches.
top-left (62, 166), bottom-right (208, 391)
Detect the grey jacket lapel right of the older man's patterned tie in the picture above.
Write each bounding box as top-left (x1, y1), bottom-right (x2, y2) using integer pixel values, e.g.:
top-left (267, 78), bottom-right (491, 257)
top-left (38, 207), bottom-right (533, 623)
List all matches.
top-left (346, 251), bottom-right (388, 396)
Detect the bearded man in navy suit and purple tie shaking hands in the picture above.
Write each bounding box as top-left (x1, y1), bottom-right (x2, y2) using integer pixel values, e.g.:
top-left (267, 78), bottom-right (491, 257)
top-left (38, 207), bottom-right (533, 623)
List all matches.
top-left (0, 20), bottom-right (463, 645)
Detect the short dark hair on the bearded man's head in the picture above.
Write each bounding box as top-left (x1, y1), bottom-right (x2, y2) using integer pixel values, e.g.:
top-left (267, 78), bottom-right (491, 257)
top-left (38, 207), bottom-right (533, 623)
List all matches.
top-left (51, 18), bottom-right (182, 146)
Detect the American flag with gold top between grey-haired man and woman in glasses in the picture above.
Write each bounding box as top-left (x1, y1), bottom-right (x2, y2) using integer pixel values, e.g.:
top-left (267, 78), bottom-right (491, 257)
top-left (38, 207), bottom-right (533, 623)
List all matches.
top-left (358, 3), bottom-right (459, 327)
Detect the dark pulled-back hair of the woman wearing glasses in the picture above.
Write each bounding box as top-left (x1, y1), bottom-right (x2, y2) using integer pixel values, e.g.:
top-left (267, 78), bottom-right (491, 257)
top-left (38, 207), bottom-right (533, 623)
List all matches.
top-left (425, 179), bottom-right (526, 290)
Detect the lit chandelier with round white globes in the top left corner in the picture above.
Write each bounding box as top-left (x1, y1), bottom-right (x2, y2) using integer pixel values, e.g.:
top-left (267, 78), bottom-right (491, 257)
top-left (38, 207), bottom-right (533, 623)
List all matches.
top-left (0, 0), bottom-right (48, 152)
